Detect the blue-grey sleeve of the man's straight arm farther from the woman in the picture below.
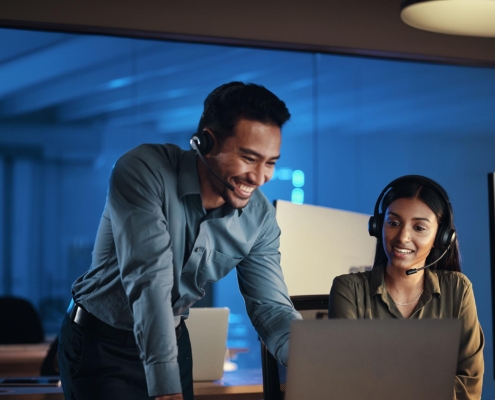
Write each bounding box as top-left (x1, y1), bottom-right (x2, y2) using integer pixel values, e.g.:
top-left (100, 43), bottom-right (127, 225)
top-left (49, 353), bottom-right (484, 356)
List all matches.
top-left (108, 155), bottom-right (182, 397)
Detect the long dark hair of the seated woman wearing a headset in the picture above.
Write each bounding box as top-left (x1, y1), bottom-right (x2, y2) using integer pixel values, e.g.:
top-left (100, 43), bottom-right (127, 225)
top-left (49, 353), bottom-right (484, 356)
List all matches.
top-left (373, 178), bottom-right (461, 271)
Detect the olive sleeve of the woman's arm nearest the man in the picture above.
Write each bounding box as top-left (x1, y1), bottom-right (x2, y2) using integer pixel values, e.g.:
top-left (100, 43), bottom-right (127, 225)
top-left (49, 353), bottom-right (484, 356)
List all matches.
top-left (328, 275), bottom-right (358, 319)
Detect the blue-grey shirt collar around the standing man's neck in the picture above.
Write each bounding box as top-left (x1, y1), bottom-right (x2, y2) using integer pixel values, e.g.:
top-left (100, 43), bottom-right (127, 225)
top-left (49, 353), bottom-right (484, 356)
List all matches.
top-left (177, 150), bottom-right (244, 217)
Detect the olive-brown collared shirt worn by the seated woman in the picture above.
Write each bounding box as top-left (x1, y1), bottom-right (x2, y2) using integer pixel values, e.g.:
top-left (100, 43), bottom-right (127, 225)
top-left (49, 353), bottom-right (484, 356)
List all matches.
top-left (329, 267), bottom-right (484, 400)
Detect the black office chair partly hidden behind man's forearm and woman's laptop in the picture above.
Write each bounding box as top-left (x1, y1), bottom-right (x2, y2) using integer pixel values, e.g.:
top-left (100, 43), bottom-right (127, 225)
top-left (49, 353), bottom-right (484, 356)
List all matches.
top-left (261, 294), bottom-right (329, 400)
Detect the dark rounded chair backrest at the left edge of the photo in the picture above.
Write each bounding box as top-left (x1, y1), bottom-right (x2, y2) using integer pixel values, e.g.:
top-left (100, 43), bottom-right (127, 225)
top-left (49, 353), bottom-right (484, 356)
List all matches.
top-left (0, 297), bottom-right (44, 344)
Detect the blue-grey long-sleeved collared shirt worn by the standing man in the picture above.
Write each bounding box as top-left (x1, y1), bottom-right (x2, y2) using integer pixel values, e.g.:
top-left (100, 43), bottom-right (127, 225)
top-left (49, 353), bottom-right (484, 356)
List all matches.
top-left (72, 145), bottom-right (301, 396)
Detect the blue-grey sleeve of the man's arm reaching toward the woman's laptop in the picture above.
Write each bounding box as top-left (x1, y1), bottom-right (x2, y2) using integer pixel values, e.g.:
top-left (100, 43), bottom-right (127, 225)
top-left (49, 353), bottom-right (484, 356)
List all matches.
top-left (237, 211), bottom-right (302, 365)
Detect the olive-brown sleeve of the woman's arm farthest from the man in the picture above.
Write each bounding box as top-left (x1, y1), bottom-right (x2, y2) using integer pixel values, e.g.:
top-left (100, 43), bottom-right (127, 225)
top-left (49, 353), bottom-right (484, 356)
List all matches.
top-left (454, 283), bottom-right (485, 400)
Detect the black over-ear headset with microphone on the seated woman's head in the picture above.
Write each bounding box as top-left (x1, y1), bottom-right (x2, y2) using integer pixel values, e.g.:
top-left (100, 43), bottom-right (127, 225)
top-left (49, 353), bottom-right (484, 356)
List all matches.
top-left (368, 175), bottom-right (456, 275)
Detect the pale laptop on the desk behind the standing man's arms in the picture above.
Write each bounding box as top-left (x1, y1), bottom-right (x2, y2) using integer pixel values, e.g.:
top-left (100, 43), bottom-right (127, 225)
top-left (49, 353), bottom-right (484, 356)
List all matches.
top-left (186, 307), bottom-right (229, 381)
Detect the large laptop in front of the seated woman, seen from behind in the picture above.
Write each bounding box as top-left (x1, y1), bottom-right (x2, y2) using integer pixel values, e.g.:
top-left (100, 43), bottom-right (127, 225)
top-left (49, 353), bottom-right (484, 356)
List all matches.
top-left (285, 319), bottom-right (461, 400)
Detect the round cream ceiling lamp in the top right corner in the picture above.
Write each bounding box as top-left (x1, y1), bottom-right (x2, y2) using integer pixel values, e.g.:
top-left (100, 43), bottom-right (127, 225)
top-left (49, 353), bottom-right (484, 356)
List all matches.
top-left (400, 0), bottom-right (495, 37)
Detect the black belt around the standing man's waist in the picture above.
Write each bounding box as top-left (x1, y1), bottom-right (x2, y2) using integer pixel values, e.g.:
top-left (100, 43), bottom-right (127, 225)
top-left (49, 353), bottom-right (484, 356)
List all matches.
top-left (69, 303), bottom-right (183, 343)
